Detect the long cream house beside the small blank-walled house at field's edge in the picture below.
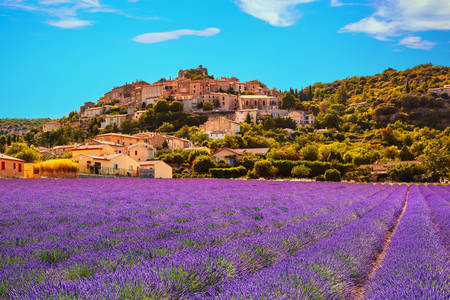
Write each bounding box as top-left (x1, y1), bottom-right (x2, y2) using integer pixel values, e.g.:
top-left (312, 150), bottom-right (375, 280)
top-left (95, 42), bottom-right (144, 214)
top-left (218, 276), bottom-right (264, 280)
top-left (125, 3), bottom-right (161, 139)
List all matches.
top-left (79, 153), bottom-right (139, 177)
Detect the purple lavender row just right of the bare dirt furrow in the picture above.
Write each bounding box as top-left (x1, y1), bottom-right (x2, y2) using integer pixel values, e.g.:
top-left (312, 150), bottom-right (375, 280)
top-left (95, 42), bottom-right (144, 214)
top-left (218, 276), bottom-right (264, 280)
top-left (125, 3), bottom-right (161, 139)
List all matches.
top-left (364, 186), bottom-right (450, 299)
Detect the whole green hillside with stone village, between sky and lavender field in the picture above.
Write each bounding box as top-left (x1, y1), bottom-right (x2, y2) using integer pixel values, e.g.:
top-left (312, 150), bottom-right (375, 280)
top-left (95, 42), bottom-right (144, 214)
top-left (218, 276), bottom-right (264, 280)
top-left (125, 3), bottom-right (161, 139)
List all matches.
top-left (0, 64), bottom-right (450, 181)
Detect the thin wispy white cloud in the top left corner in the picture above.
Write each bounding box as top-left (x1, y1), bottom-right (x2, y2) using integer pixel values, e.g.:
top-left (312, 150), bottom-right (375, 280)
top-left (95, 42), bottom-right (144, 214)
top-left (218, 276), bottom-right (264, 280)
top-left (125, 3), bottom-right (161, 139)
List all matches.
top-left (0, 0), bottom-right (157, 29)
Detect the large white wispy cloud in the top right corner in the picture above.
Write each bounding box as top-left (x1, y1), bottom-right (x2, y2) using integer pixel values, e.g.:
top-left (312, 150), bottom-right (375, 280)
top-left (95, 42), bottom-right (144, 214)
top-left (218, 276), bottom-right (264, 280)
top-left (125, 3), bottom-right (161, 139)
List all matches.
top-left (339, 0), bottom-right (450, 49)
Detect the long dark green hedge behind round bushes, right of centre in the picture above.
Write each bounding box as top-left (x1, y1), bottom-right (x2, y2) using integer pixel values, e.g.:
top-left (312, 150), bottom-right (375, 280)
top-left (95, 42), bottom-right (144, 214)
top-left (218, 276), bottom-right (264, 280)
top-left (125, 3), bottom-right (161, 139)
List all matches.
top-left (272, 160), bottom-right (353, 178)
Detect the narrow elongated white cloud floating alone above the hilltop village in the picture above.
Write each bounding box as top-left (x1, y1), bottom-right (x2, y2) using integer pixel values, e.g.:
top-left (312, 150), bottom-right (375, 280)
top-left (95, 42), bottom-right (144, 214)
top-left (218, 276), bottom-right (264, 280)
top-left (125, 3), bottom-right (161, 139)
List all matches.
top-left (133, 28), bottom-right (220, 44)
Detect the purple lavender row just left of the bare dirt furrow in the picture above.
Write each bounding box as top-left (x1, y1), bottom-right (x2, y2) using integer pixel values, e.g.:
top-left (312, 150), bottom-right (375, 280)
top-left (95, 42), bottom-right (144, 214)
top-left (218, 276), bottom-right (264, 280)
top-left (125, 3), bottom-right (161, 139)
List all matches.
top-left (214, 186), bottom-right (406, 299)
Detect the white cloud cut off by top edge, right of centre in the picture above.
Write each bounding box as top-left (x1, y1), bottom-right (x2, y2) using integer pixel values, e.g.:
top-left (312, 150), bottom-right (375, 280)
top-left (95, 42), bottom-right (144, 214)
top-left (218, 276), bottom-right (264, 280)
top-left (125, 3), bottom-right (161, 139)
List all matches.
top-left (235, 0), bottom-right (316, 27)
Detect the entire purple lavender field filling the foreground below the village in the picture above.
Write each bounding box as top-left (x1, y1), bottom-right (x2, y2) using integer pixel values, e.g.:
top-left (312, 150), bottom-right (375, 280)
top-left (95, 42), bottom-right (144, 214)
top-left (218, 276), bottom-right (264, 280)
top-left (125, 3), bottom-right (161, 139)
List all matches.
top-left (0, 179), bottom-right (450, 299)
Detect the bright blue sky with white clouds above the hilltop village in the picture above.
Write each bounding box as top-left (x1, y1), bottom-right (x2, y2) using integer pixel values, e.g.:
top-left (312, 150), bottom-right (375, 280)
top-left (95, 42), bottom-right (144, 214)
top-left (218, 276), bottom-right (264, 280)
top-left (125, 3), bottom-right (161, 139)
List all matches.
top-left (0, 0), bottom-right (450, 118)
